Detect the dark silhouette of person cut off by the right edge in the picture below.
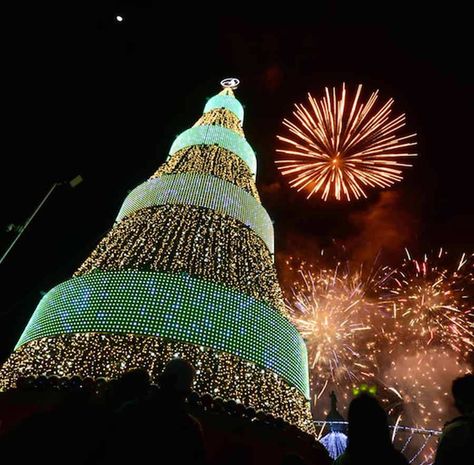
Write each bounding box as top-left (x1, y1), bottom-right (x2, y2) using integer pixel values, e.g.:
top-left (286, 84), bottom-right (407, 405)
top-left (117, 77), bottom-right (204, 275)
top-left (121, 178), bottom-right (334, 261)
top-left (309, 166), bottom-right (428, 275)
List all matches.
top-left (434, 373), bottom-right (474, 465)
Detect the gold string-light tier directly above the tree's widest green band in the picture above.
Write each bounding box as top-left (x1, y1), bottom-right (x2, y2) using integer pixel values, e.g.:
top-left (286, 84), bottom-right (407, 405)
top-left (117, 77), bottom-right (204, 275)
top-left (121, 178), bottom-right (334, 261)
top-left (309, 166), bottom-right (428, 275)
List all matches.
top-left (75, 205), bottom-right (288, 316)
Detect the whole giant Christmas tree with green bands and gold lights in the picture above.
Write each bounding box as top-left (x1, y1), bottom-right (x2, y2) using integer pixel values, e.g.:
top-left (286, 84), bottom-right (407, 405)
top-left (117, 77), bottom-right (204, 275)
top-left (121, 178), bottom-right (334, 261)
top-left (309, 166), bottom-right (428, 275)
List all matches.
top-left (0, 80), bottom-right (312, 431)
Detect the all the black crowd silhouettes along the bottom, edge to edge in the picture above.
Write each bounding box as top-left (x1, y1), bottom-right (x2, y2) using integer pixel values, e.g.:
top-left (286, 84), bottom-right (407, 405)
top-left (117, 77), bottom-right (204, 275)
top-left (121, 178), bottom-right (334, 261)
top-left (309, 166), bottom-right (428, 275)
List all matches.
top-left (0, 359), bottom-right (474, 465)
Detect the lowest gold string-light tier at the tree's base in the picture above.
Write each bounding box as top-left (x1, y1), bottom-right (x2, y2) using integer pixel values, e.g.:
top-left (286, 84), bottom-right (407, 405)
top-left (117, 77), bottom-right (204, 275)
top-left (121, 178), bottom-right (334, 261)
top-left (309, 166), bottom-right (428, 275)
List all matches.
top-left (0, 333), bottom-right (314, 433)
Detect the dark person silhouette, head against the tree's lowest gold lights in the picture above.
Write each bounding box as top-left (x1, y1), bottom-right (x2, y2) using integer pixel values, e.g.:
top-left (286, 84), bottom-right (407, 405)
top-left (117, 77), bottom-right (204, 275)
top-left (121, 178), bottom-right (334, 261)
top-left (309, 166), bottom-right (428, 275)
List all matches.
top-left (105, 359), bottom-right (206, 465)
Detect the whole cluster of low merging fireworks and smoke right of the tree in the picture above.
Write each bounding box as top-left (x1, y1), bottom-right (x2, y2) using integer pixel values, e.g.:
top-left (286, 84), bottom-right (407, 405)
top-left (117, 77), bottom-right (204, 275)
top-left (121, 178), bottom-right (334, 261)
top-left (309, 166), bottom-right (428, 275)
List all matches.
top-left (287, 250), bottom-right (474, 428)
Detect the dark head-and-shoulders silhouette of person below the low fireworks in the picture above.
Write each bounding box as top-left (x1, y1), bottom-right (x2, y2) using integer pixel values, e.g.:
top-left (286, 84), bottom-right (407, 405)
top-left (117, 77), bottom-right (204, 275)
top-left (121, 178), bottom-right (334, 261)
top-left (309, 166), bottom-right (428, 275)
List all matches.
top-left (334, 393), bottom-right (408, 465)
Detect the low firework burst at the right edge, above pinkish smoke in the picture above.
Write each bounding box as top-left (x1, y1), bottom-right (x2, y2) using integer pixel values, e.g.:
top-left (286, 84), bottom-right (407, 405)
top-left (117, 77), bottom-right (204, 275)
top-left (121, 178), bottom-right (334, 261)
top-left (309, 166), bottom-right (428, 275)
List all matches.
top-left (381, 249), bottom-right (474, 355)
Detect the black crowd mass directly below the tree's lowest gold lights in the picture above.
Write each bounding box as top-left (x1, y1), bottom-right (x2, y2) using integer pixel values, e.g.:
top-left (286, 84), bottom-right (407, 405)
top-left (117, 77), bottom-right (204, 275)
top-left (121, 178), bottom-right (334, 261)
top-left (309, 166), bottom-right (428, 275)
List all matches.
top-left (0, 359), bottom-right (331, 465)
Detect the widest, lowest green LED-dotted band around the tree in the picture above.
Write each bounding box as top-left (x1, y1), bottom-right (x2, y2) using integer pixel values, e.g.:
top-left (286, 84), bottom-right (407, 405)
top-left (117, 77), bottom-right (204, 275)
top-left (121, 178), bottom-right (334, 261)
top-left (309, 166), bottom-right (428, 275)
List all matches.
top-left (17, 270), bottom-right (309, 396)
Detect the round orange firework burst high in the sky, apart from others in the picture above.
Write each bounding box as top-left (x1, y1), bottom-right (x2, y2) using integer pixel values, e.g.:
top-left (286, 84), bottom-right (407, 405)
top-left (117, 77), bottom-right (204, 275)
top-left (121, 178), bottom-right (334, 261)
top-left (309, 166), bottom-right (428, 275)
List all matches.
top-left (276, 84), bottom-right (416, 201)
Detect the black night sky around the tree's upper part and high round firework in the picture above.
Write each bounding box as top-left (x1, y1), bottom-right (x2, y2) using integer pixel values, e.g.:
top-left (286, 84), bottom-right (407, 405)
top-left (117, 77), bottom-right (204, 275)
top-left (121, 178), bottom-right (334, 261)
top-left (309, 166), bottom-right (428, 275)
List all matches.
top-left (0, 1), bottom-right (474, 359)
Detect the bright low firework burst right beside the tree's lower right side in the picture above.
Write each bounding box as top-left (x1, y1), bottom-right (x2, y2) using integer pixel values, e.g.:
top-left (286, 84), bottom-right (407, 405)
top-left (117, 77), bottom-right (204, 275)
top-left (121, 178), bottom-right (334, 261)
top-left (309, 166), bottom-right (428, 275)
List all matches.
top-left (287, 260), bottom-right (382, 410)
